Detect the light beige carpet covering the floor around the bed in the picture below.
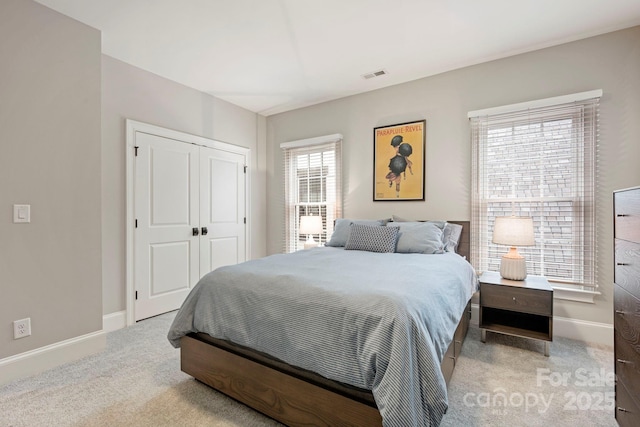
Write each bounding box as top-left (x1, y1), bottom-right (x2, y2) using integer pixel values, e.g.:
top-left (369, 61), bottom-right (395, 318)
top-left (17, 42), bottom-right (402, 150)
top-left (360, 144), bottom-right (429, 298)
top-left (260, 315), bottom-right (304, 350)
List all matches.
top-left (0, 313), bottom-right (617, 427)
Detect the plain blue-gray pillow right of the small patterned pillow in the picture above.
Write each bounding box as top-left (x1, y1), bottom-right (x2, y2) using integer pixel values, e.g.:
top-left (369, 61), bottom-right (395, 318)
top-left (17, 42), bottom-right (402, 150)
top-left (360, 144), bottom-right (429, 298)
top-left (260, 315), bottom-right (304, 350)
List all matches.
top-left (387, 221), bottom-right (445, 254)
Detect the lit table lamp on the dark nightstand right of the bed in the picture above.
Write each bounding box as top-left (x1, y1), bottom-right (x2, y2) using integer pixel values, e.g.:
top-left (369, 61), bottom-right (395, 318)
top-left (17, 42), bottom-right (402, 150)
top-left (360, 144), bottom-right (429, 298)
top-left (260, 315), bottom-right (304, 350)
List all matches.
top-left (492, 216), bottom-right (535, 280)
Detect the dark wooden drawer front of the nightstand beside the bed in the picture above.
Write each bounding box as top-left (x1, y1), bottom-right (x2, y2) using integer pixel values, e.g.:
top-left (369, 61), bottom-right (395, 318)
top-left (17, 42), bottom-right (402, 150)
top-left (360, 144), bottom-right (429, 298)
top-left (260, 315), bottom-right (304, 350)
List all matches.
top-left (480, 283), bottom-right (553, 316)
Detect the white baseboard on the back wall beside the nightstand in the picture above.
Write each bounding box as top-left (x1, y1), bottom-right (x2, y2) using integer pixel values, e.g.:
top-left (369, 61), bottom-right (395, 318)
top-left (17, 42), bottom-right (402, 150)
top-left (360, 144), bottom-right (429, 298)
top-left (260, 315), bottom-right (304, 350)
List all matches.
top-left (471, 304), bottom-right (613, 348)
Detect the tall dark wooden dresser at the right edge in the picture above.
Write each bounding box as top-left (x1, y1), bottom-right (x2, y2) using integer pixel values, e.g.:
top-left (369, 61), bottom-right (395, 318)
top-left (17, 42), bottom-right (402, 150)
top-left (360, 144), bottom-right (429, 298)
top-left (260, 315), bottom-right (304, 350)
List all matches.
top-left (613, 187), bottom-right (640, 426)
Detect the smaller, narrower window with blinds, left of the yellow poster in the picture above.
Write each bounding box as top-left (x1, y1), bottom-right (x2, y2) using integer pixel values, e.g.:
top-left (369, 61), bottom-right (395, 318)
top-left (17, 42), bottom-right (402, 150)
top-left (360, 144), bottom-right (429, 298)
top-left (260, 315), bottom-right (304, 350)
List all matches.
top-left (280, 134), bottom-right (342, 252)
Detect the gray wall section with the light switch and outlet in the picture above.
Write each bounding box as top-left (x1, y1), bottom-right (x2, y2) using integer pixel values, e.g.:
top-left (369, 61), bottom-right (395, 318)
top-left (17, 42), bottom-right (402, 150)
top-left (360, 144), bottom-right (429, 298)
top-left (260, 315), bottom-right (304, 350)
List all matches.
top-left (0, 0), bottom-right (102, 359)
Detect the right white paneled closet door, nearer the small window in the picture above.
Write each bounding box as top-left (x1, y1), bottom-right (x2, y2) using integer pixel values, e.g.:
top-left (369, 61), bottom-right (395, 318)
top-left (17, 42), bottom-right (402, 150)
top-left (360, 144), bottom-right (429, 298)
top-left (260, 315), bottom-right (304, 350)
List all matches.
top-left (200, 147), bottom-right (246, 276)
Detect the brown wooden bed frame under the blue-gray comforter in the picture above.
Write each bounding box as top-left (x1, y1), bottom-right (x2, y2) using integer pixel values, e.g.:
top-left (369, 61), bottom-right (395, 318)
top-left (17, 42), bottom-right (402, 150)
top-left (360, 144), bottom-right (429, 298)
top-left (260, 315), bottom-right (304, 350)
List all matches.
top-left (180, 221), bottom-right (471, 426)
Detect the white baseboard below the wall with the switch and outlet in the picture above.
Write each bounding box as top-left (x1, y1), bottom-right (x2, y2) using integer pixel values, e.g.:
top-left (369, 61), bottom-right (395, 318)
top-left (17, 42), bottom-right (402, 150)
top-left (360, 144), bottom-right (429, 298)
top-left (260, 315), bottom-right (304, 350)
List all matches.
top-left (0, 331), bottom-right (107, 385)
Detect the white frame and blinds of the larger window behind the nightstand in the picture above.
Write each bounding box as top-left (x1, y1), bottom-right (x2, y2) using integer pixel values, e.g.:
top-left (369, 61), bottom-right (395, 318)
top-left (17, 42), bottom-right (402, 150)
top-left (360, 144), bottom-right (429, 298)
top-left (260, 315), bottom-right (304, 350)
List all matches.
top-left (468, 90), bottom-right (602, 303)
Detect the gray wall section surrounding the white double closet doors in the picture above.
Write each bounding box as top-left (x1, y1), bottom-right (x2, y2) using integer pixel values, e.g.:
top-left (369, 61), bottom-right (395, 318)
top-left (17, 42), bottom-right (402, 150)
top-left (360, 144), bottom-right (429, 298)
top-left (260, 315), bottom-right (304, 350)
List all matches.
top-left (102, 55), bottom-right (266, 314)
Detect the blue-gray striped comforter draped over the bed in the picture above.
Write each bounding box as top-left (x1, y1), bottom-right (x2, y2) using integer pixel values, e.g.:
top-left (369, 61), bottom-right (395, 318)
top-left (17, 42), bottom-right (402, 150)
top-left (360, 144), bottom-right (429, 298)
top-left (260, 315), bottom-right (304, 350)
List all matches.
top-left (168, 247), bottom-right (477, 426)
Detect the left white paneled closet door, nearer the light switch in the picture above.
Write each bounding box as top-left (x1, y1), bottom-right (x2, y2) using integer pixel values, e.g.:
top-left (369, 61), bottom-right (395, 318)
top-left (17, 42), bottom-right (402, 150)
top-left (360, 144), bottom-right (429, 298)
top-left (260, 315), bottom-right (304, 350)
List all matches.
top-left (134, 132), bottom-right (200, 321)
